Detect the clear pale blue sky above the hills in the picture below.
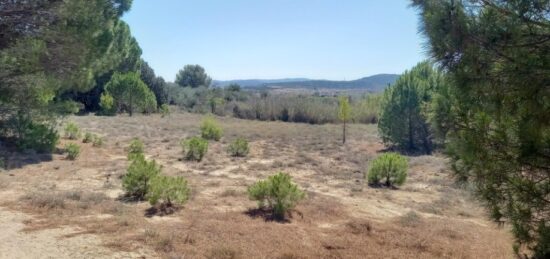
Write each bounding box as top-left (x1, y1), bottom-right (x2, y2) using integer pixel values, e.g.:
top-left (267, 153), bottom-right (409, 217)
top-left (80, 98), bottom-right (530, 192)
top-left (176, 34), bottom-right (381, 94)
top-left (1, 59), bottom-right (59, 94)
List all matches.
top-left (124, 0), bottom-right (425, 81)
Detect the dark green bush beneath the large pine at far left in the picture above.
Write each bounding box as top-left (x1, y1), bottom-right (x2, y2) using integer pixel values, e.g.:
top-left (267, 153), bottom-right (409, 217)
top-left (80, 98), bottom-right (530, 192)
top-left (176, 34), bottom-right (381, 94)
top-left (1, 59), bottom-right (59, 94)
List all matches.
top-left (16, 121), bottom-right (59, 153)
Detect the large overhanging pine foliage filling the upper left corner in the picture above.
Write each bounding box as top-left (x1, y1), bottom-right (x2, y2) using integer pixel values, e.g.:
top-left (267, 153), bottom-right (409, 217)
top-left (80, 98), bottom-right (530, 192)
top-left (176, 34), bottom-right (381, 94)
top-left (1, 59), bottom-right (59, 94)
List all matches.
top-left (0, 0), bottom-right (136, 150)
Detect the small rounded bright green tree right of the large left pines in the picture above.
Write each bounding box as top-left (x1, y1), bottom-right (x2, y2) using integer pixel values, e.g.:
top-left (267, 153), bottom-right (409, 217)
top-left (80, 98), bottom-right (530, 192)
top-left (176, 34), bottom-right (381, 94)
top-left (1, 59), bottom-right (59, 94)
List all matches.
top-left (105, 72), bottom-right (157, 116)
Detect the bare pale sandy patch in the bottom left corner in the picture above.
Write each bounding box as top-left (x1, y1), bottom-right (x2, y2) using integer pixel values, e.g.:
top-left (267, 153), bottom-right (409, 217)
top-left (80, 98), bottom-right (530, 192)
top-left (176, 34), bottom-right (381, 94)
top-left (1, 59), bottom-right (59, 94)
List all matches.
top-left (0, 207), bottom-right (149, 259)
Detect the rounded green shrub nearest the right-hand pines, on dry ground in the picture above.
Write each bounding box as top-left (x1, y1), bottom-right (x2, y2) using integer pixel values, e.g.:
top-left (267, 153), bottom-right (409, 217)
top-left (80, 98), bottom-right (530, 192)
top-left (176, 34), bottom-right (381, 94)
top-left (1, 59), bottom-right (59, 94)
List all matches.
top-left (367, 153), bottom-right (408, 187)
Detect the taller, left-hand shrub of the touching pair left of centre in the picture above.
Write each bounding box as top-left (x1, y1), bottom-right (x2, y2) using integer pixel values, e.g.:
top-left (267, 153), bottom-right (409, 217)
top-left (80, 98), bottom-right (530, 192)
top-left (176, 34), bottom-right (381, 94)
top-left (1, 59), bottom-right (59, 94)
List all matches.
top-left (122, 156), bottom-right (161, 200)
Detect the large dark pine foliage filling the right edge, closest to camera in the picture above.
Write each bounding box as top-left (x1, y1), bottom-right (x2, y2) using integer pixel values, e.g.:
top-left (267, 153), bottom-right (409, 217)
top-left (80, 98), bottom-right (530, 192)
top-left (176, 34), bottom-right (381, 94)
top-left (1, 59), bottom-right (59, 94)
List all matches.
top-left (413, 0), bottom-right (550, 258)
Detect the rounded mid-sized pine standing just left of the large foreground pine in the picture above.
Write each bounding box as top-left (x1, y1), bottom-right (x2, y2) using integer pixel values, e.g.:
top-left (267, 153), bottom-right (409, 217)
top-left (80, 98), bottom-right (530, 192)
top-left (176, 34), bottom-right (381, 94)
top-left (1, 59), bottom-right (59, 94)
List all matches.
top-left (378, 61), bottom-right (443, 154)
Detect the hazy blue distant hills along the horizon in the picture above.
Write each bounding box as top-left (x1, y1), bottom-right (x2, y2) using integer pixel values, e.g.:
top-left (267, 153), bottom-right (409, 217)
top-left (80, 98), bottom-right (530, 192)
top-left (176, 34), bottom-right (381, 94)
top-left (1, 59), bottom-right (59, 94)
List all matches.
top-left (214, 74), bottom-right (399, 92)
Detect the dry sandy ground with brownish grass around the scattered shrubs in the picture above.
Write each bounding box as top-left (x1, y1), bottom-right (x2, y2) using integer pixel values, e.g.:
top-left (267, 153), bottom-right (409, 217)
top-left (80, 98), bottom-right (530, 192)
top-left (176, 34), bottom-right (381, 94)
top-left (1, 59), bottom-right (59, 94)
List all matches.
top-left (0, 113), bottom-right (513, 259)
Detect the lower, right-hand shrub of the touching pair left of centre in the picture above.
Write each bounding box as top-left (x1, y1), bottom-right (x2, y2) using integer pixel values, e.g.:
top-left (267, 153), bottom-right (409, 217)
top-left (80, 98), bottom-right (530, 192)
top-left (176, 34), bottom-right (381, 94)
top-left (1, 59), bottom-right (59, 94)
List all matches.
top-left (147, 175), bottom-right (189, 207)
